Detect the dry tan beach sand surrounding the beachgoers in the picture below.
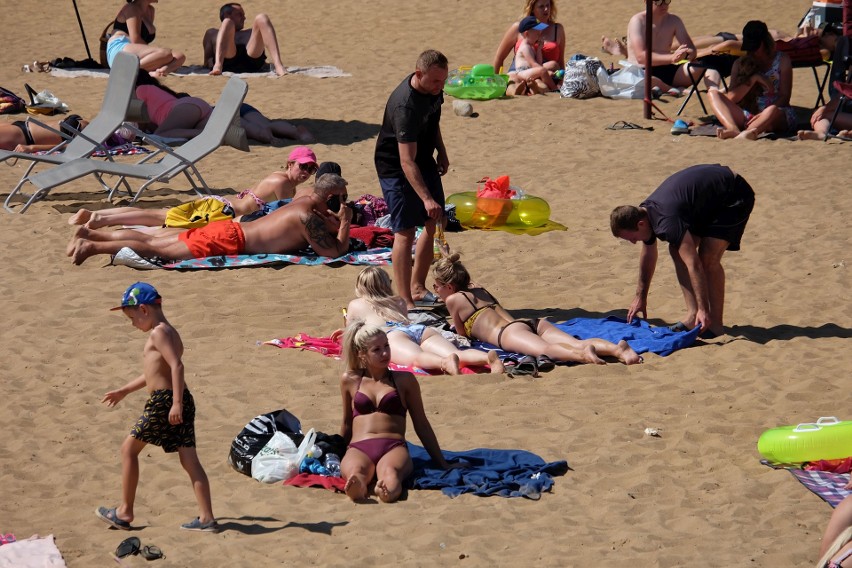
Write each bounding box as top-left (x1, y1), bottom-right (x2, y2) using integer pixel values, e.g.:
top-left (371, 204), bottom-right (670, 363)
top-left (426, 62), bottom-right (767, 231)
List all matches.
top-left (0, 0), bottom-right (852, 567)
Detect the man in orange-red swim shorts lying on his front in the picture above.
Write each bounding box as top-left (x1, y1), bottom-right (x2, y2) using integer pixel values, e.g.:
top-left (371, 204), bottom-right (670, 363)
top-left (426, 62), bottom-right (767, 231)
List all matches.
top-left (66, 174), bottom-right (352, 264)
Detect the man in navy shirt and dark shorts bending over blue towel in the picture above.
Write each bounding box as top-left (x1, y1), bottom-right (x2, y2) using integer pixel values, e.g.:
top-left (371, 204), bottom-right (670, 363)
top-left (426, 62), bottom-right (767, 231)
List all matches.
top-left (610, 164), bottom-right (754, 337)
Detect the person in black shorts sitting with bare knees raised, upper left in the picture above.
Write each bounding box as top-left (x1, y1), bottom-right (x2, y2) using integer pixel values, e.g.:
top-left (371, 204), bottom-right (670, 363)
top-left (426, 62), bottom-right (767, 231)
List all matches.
top-left (203, 2), bottom-right (287, 76)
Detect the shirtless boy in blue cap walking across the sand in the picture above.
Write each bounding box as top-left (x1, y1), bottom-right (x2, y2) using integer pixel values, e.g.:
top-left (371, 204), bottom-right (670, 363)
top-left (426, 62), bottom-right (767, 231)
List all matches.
top-left (95, 282), bottom-right (219, 532)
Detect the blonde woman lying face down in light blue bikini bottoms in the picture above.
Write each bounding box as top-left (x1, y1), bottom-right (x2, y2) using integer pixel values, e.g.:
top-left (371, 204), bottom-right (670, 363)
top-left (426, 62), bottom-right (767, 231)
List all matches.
top-left (346, 266), bottom-right (503, 375)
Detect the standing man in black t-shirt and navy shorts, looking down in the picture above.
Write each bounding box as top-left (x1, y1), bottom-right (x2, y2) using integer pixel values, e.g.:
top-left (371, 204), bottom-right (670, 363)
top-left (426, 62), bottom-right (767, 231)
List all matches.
top-left (375, 49), bottom-right (450, 308)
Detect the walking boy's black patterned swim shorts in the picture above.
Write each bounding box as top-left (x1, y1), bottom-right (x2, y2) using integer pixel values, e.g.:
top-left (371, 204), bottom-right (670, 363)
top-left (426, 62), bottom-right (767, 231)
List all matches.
top-left (130, 389), bottom-right (195, 453)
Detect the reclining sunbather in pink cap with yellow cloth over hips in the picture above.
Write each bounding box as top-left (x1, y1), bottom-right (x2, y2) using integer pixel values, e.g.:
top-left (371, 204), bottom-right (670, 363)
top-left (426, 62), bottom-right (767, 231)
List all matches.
top-left (68, 150), bottom-right (322, 229)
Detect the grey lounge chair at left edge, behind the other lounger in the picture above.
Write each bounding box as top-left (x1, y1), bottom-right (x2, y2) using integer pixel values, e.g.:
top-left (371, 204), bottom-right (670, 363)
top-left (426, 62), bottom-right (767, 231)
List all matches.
top-left (0, 48), bottom-right (139, 213)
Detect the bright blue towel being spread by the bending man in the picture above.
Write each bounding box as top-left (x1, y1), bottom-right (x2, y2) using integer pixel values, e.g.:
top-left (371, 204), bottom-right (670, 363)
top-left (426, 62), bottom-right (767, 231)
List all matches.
top-left (554, 316), bottom-right (701, 357)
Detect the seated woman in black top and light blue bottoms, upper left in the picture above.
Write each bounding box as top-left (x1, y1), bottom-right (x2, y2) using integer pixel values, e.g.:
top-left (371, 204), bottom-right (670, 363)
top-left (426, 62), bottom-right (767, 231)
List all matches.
top-left (106, 0), bottom-right (186, 77)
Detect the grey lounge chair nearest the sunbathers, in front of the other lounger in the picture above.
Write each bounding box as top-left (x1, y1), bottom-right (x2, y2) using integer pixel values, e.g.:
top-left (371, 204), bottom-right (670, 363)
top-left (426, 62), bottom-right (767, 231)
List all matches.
top-left (24, 77), bottom-right (248, 207)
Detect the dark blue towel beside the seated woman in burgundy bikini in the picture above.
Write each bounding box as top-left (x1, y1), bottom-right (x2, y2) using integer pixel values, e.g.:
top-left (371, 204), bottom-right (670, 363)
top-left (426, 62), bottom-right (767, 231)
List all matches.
top-left (408, 442), bottom-right (569, 499)
